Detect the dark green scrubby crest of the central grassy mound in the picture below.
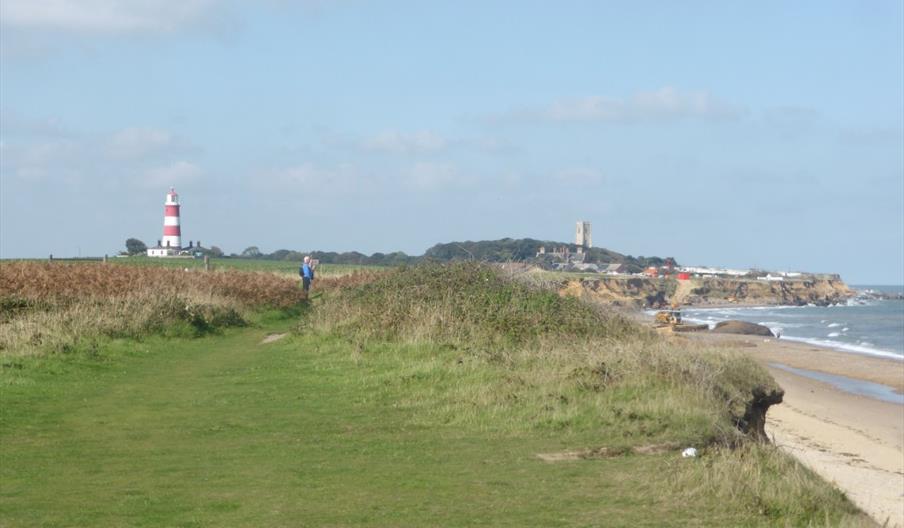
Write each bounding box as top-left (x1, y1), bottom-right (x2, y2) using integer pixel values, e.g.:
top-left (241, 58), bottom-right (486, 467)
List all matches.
top-left (310, 263), bottom-right (646, 348)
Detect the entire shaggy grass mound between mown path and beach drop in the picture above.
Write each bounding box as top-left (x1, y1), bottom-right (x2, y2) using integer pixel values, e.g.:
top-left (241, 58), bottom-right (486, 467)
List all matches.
top-left (301, 263), bottom-right (777, 446)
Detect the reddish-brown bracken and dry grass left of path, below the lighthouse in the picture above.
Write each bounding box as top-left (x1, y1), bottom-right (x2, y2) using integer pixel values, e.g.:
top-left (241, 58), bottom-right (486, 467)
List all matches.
top-left (0, 262), bottom-right (305, 355)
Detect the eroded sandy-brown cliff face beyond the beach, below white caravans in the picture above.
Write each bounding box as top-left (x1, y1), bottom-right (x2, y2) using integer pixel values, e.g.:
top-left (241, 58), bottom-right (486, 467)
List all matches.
top-left (560, 277), bottom-right (854, 308)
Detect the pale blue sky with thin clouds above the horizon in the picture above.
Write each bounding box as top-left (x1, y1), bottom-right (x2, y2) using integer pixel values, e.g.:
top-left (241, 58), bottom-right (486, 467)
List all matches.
top-left (0, 0), bottom-right (904, 284)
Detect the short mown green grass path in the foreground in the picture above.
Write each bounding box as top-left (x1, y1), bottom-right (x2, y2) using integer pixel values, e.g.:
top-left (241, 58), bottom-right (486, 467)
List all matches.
top-left (0, 325), bottom-right (784, 526)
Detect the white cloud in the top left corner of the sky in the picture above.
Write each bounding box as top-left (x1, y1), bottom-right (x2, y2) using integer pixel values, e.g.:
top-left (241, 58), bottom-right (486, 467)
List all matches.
top-left (0, 0), bottom-right (222, 34)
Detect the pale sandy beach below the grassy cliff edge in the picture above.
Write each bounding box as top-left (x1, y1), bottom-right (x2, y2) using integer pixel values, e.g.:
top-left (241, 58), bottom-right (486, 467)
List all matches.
top-left (676, 334), bottom-right (904, 527)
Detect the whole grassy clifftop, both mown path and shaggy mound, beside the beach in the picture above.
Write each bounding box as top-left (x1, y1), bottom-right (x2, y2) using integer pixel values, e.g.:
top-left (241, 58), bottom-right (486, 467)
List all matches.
top-left (0, 266), bottom-right (869, 527)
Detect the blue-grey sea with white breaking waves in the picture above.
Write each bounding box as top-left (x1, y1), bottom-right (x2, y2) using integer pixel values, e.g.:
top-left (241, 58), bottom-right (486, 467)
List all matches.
top-left (681, 285), bottom-right (904, 361)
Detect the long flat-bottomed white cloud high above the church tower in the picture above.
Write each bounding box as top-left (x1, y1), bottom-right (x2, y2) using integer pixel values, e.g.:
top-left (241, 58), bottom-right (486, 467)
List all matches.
top-left (504, 86), bottom-right (744, 123)
